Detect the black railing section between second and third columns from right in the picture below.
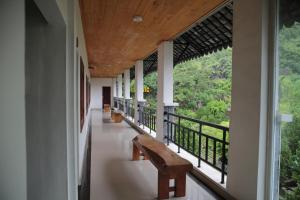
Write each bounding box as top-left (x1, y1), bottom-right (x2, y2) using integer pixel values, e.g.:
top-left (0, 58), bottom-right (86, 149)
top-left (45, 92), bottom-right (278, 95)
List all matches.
top-left (138, 105), bottom-right (156, 133)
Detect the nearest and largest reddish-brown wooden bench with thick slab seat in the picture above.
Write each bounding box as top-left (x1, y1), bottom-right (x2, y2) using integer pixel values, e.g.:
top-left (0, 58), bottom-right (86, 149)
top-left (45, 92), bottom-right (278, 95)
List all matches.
top-left (132, 134), bottom-right (193, 199)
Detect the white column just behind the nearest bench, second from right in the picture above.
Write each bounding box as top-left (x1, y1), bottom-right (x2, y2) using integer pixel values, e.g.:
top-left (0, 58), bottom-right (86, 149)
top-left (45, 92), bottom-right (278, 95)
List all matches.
top-left (156, 41), bottom-right (178, 142)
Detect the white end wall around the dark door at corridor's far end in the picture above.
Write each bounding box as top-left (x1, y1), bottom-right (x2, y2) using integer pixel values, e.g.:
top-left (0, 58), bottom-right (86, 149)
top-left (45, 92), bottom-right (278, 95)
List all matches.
top-left (91, 78), bottom-right (113, 109)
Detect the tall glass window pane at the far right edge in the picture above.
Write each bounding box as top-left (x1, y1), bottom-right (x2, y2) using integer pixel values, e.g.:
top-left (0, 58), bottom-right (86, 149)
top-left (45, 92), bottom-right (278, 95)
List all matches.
top-left (272, 0), bottom-right (300, 200)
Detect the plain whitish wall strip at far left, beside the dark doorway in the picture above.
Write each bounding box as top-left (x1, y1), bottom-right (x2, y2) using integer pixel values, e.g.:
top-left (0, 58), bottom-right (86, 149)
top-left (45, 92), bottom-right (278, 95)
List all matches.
top-left (0, 0), bottom-right (27, 200)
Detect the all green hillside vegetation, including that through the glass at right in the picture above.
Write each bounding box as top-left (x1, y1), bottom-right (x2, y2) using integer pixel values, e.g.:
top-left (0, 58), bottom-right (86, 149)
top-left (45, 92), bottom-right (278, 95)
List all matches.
top-left (131, 24), bottom-right (300, 200)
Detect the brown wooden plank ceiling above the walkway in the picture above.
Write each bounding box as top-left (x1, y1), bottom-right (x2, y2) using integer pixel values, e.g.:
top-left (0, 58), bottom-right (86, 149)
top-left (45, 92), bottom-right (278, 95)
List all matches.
top-left (80, 0), bottom-right (225, 77)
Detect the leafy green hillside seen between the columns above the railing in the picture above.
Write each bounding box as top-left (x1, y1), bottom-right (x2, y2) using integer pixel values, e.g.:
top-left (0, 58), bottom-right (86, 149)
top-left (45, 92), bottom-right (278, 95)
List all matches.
top-left (144, 49), bottom-right (231, 124)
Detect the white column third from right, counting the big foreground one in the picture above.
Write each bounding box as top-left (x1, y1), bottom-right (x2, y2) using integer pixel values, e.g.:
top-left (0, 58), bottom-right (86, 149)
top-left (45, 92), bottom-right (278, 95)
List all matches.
top-left (134, 60), bottom-right (146, 125)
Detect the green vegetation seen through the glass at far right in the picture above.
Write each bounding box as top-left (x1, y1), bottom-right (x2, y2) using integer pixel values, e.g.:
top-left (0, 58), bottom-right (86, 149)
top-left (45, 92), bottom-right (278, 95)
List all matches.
top-left (279, 24), bottom-right (300, 200)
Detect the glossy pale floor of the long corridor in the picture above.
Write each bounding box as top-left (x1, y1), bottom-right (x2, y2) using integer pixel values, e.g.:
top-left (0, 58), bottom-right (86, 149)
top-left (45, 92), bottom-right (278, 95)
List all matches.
top-left (90, 110), bottom-right (218, 200)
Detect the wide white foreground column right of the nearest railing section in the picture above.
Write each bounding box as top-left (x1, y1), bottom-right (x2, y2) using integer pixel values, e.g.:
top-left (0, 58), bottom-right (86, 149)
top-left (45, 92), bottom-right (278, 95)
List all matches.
top-left (227, 0), bottom-right (269, 200)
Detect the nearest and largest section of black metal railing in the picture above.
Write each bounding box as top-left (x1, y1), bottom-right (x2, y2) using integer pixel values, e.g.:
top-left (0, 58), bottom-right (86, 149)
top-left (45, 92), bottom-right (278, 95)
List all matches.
top-left (165, 112), bottom-right (229, 183)
